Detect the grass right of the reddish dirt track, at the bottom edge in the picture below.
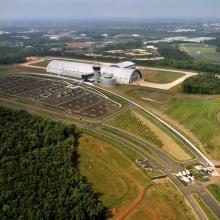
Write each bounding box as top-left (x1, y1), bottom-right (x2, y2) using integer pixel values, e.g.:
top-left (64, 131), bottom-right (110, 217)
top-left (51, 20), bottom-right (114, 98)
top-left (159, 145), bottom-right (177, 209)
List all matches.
top-left (125, 183), bottom-right (195, 220)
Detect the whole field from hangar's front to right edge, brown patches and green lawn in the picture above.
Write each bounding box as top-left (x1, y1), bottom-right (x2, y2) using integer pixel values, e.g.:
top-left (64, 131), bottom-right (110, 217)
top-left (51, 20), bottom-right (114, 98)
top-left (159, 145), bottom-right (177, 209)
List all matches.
top-left (117, 86), bottom-right (220, 160)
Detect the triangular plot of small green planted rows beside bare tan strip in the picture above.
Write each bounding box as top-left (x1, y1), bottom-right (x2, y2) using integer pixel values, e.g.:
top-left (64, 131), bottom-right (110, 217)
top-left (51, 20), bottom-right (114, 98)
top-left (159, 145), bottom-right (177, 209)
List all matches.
top-left (107, 110), bottom-right (163, 147)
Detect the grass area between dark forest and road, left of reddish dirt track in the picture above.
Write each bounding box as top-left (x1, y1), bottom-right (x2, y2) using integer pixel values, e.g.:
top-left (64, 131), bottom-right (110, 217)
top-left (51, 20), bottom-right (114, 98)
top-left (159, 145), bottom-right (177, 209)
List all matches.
top-left (79, 135), bottom-right (151, 210)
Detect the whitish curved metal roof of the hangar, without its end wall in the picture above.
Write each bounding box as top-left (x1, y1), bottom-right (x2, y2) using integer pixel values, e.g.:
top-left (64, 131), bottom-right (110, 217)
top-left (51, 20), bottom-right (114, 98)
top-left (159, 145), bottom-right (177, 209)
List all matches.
top-left (47, 60), bottom-right (140, 84)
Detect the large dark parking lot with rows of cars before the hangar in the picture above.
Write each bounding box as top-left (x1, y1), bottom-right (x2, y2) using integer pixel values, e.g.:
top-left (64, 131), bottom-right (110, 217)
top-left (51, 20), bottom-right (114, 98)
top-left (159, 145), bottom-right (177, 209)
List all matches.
top-left (0, 74), bottom-right (119, 118)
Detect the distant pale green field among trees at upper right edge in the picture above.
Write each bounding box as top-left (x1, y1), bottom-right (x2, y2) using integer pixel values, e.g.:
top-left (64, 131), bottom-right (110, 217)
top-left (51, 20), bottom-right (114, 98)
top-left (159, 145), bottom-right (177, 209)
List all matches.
top-left (180, 44), bottom-right (220, 64)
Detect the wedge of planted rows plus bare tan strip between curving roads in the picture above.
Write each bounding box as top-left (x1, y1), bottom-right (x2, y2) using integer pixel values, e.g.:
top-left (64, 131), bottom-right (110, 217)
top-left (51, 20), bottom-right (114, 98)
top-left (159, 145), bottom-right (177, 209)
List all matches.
top-left (107, 110), bottom-right (192, 161)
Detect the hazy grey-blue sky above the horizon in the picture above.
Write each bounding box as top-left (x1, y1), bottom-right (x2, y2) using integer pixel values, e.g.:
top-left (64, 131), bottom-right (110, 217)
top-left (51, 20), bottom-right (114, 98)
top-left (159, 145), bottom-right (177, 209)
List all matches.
top-left (0, 0), bottom-right (220, 20)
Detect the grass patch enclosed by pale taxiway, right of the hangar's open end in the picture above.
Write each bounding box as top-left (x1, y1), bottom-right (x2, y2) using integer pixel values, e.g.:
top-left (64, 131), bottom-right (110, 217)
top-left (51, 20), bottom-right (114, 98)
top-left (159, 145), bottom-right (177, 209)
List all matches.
top-left (139, 68), bottom-right (184, 83)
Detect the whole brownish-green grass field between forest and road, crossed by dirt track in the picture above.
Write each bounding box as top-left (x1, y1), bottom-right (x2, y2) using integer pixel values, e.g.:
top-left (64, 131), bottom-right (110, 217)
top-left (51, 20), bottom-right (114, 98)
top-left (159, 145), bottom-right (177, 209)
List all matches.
top-left (79, 135), bottom-right (195, 220)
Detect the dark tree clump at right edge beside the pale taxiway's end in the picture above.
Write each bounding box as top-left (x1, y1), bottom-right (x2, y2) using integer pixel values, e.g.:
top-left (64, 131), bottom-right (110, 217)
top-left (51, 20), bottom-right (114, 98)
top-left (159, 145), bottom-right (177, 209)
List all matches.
top-left (182, 74), bottom-right (220, 95)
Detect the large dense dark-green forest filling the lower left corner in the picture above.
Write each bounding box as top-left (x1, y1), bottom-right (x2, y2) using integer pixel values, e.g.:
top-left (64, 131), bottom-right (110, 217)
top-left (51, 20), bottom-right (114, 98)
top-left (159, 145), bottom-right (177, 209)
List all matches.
top-left (0, 107), bottom-right (105, 220)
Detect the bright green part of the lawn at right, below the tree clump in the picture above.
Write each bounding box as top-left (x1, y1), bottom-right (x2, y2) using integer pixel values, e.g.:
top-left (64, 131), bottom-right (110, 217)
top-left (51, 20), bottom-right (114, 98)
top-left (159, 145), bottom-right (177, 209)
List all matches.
top-left (164, 96), bottom-right (220, 160)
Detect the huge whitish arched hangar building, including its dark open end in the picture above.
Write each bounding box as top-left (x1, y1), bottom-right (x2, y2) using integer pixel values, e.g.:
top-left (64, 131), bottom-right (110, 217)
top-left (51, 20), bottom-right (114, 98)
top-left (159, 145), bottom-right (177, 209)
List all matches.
top-left (47, 60), bottom-right (141, 85)
